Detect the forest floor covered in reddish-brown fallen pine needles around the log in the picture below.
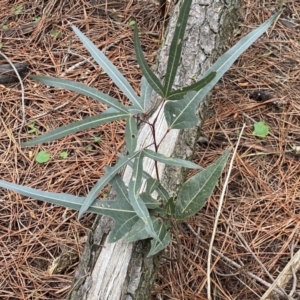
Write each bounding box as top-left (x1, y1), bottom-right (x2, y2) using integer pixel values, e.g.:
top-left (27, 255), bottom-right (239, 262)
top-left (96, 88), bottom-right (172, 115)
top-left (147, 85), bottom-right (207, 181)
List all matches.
top-left (0, 0), bottom-right (300, 300)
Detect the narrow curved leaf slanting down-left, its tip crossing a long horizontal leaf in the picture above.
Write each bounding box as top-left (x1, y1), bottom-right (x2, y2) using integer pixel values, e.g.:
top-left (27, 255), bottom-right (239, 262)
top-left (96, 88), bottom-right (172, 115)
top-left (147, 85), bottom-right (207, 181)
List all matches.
top-left (78, 151), bottom-right (141, 219)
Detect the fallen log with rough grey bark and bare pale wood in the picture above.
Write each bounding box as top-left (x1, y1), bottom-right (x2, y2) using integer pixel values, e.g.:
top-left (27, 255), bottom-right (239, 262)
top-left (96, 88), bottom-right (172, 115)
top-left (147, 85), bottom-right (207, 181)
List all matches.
top-left (68, 0), bottom-right (239, 300)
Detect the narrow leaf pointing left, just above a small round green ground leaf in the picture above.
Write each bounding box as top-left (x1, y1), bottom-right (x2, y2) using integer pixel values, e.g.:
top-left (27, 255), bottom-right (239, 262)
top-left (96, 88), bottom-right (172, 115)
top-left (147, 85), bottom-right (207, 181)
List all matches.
top-left (21, 109), bottom-right (130, 147)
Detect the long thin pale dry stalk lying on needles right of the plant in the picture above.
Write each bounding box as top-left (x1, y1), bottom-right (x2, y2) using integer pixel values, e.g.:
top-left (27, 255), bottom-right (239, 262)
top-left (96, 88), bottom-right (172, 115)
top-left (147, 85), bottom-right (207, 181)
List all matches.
top-left (207, 124), bottom-right (246, 300)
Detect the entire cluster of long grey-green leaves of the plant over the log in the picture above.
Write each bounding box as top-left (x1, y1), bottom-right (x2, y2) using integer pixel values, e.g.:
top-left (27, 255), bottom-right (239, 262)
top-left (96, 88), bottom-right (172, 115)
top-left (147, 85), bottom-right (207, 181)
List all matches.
top-left (0, 0), bottom-right (277, 256)
